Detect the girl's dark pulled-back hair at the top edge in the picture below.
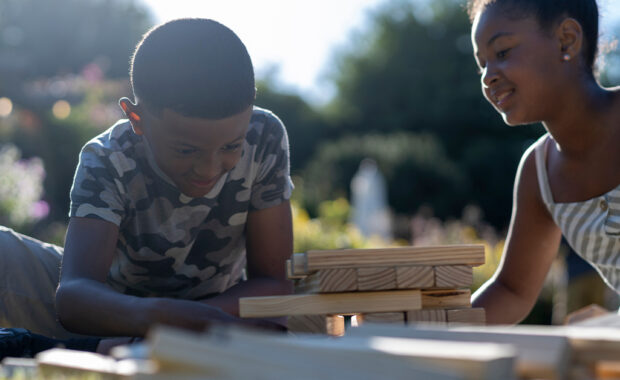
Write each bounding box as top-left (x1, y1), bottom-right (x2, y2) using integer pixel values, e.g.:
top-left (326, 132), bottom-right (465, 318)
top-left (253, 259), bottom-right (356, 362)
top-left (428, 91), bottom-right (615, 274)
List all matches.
top-left (467, 0), bottom-right (599, 70)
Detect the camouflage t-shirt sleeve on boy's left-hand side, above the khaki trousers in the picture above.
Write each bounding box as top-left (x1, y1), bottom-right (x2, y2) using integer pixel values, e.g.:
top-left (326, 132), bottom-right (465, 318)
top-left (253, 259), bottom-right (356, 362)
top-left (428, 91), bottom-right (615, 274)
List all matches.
top-left (69, 143), bottom-right (125, 226)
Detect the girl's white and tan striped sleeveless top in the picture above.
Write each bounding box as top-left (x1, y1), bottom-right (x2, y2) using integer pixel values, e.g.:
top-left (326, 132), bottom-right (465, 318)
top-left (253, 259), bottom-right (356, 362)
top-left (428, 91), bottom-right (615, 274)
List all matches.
top-left (534, 134), bottom-right (620, 293)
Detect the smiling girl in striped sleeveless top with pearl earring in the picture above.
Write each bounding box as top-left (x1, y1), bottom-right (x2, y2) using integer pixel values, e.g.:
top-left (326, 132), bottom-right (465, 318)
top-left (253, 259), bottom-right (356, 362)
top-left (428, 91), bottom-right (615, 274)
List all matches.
top-left (469, 0), bottom-right (620, 324)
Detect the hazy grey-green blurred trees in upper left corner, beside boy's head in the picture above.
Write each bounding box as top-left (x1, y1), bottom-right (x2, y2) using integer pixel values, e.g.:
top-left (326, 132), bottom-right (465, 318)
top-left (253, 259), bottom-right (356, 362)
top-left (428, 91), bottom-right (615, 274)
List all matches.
top-left (0, 0), bottom-right (152, 81)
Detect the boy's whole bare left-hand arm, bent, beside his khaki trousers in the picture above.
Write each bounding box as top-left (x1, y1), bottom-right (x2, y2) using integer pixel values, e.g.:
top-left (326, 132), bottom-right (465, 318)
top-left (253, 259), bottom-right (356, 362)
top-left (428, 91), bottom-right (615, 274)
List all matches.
top-left (56, 217), bottom-right (237, 336)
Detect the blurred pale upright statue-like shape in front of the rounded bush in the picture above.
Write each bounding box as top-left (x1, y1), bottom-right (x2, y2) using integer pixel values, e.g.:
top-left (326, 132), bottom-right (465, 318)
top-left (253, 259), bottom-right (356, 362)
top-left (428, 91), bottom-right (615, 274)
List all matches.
top-left (351, 158), bottom-right (392, 241)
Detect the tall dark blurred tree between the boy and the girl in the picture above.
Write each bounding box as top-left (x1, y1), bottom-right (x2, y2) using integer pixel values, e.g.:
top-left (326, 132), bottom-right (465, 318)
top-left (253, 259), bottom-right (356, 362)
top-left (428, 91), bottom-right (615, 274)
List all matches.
top-left (322, 0), bottom-right (542, 228)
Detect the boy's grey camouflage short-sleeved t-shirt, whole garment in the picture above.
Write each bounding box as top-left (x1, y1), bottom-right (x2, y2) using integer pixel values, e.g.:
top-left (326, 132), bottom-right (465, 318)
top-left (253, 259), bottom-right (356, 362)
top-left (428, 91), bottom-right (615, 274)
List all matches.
top-left (69, 108), bottom-right (293, 299)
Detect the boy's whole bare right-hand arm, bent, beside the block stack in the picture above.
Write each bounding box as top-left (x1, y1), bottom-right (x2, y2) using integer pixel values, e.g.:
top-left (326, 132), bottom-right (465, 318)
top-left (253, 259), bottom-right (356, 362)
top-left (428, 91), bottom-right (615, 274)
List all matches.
top-left (204, 200), bottom-right (293, 316)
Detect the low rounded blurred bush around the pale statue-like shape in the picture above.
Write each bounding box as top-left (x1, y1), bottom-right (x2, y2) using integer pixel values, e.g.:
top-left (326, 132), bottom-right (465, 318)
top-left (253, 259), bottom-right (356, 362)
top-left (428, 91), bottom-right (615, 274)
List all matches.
top-left (303, 132), bottom-right (469, 217)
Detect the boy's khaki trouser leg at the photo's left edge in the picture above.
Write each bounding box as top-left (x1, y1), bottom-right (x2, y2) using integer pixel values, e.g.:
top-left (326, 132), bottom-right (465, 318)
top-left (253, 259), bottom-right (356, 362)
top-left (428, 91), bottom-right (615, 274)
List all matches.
top-left (0, 226), bottom-right (81, 339)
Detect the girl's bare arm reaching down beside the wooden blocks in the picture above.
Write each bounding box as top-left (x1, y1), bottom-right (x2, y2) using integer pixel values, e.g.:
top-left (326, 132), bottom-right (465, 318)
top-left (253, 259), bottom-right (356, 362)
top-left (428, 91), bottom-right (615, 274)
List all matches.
top-left (473, 149), bottom-right (562, 324)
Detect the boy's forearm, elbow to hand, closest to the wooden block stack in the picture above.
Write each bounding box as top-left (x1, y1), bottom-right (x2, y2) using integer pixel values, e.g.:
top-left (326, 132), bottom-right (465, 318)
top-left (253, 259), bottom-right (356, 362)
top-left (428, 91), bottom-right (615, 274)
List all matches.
top-left (202, 277), bottom-right (293, 316)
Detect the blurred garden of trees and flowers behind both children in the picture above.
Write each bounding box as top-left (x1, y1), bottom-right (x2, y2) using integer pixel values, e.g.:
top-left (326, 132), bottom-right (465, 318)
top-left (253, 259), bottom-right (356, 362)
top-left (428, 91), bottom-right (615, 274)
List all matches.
top-left (0, 0), bottom-right (620, 323)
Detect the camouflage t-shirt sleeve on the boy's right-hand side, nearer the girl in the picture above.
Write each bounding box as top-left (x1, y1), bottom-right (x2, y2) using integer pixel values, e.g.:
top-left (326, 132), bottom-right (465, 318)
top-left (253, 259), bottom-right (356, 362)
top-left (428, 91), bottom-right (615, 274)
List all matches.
top-left (250, 113), bottom-right (293, 210)
